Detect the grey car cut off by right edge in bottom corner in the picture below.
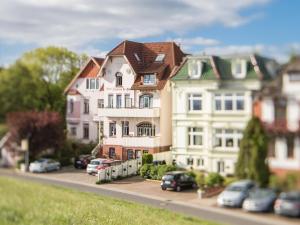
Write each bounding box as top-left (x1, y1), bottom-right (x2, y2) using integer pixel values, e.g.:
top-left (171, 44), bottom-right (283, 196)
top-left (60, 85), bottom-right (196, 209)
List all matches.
top-left (274, 191), bottom-right (300, 217)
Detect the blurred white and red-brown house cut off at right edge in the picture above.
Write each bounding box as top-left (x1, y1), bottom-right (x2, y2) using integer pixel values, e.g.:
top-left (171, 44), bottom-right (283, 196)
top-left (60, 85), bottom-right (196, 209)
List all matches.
top-left (254, 57), bottom-right (300, 174)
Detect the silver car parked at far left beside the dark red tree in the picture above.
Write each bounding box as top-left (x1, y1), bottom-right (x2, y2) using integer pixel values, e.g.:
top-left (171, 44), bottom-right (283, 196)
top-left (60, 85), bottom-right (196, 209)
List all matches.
top-left (29, 158), bottom-right (61, 173)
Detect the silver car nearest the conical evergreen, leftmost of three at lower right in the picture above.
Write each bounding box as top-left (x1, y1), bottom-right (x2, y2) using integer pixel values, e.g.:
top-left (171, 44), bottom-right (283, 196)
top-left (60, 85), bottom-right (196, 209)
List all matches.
top-left (217, 180), bottom-right (255, 208)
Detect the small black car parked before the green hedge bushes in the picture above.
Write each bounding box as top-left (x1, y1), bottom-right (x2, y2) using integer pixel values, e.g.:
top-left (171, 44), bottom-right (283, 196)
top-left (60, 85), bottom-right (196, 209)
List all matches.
top-left (160, 171), bottom-right (197, 191)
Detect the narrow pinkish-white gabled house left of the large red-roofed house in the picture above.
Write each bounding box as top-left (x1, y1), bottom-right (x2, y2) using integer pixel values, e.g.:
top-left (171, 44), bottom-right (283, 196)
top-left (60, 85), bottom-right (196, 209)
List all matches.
top-left (65, 57), bottom-right (104, 143)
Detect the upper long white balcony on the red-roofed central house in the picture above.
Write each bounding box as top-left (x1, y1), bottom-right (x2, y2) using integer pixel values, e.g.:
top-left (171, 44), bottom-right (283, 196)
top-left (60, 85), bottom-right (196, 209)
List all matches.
top-left (98, 108), bottom-right (160, 118)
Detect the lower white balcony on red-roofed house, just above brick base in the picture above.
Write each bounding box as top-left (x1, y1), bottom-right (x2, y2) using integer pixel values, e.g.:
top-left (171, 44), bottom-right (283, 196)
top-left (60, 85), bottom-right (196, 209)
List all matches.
top-left (103, 136), bottom-right (160, 148)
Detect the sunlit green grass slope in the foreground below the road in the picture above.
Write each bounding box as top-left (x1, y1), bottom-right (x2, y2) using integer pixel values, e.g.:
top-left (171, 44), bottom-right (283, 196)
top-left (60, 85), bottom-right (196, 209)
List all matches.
top-left (0, 177), bottom-right (223, 225)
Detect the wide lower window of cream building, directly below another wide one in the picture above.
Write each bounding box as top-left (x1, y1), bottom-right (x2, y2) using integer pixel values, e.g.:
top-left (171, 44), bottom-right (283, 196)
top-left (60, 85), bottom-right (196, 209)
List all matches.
top-left (214, 129), bottom-right (243, 149)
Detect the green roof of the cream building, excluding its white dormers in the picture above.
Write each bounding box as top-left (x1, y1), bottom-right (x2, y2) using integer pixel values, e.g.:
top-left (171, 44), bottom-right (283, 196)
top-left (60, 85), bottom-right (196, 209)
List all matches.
top-left (172, 54), bottom-right (277, 81)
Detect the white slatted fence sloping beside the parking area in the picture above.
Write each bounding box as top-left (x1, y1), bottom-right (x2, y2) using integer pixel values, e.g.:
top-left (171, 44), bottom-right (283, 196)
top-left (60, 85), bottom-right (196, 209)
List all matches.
top-left (98, 159), bottom-right (142, 182)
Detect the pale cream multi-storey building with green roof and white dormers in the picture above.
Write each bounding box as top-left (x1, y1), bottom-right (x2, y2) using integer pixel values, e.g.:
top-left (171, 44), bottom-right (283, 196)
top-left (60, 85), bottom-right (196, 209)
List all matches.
top-left (171, 55), bottom-right (277, 175)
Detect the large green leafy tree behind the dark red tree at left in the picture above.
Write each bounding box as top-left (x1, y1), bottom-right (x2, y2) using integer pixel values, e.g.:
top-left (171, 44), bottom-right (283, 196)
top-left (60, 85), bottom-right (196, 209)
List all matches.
top-left (0, 47), bottom-right (87, 121)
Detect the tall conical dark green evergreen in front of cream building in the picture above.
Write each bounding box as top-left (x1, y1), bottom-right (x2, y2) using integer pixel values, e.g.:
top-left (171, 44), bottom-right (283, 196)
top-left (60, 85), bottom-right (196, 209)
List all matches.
top-left (236, 117), bottom-right (270, 187)
